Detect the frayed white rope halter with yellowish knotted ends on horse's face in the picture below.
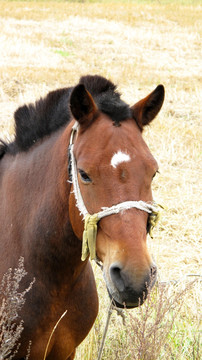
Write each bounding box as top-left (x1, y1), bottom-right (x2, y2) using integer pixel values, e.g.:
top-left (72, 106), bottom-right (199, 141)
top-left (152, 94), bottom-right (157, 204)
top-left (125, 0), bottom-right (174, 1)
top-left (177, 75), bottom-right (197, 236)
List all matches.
top-left (69, 122), bottom-right (163, 261)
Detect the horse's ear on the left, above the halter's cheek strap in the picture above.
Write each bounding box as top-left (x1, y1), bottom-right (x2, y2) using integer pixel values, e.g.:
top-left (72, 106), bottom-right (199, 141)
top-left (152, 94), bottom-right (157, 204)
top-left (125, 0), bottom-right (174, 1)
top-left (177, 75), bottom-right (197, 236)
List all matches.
top-left (70, 84), bottom-right (98, 127)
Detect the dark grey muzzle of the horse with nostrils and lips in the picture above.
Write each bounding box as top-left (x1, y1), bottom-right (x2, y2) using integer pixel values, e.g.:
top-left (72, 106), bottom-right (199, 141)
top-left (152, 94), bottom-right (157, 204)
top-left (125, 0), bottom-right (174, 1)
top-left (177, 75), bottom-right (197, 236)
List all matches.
top-left (103, 263), bottom-right (157, 309)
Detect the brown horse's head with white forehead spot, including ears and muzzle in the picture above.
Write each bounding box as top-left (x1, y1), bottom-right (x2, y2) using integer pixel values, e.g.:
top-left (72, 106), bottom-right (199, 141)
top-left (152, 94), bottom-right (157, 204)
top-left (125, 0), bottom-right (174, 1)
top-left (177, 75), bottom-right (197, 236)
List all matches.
top-left (69, 79), bottom-right (164, 308)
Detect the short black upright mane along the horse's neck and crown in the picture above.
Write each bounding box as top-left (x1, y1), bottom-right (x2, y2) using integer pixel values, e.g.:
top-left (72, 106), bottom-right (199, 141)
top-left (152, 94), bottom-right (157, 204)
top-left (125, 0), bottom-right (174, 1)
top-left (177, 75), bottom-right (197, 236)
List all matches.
top-left (0, 75), bottom-right (131, 158)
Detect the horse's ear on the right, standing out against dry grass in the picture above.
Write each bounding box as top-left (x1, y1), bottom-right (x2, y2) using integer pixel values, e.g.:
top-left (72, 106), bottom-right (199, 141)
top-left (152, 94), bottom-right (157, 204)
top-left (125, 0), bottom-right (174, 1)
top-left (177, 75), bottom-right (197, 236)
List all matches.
top-left (131, 85), bottom-right (165, 131)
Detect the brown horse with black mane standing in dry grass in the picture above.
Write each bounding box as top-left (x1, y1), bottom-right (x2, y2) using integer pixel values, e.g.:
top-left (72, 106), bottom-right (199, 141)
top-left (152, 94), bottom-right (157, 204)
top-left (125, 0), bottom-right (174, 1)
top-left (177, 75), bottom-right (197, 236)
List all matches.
top-left (0, 75), bottom-right (164, 360)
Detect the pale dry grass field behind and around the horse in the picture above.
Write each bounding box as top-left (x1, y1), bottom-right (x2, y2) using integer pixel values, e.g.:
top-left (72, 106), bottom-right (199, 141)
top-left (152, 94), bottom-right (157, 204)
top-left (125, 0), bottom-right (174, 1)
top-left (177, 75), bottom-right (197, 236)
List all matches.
top-left (0, 0), bottom-right (202, 360)
